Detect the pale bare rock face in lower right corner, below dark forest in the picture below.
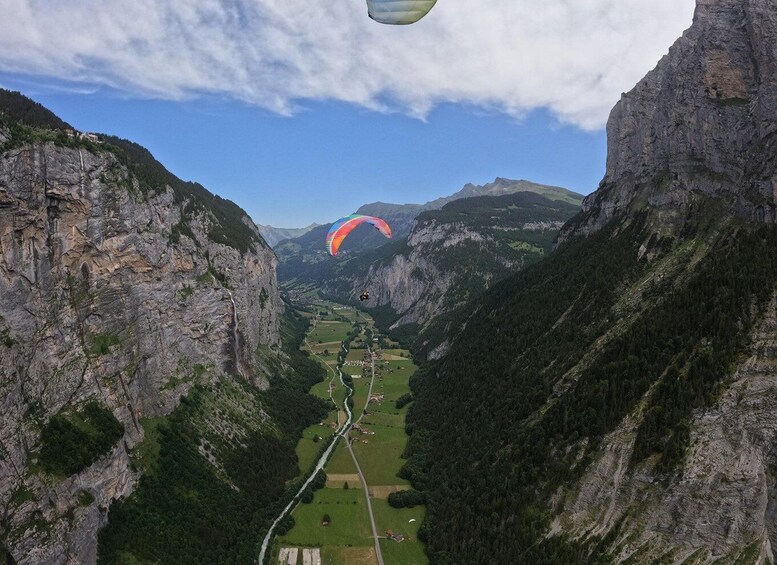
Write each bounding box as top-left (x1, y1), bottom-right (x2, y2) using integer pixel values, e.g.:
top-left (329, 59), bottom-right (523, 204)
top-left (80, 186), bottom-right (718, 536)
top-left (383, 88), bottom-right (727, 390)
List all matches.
top-left (553, 299), bottom-right (777, 563)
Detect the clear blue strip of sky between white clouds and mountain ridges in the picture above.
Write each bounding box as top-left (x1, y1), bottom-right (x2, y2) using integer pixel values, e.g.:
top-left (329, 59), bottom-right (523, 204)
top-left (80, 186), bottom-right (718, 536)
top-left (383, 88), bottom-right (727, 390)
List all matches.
top-left (0, 74), bottom-right (606, 227)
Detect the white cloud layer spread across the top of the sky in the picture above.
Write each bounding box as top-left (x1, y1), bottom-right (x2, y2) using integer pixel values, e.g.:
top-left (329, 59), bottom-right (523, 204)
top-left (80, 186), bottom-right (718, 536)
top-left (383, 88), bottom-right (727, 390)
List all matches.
top-left (0, 0), bottom-right (693, 128)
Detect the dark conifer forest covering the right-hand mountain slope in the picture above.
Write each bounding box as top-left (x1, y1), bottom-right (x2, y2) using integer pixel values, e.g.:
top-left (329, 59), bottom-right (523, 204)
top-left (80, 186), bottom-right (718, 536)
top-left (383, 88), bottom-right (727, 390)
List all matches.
top-left (403, 215), bottom-right (777, 564)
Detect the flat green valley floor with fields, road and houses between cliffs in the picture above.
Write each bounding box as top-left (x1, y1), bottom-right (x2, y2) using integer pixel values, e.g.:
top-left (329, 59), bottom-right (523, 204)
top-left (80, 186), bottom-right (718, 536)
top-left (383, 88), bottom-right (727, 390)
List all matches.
top-left (269, 301), bottom-right (428, 565)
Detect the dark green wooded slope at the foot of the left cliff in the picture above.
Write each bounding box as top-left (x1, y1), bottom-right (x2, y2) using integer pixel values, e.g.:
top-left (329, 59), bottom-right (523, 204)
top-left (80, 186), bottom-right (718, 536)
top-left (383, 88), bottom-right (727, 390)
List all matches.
top-left (99, 313), bottom-right (327, 564)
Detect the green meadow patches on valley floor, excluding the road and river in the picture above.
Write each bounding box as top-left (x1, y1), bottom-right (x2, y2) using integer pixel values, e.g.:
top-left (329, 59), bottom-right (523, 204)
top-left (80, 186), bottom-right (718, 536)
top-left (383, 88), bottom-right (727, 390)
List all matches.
top-left (273, 303), bottom-right (428, 565)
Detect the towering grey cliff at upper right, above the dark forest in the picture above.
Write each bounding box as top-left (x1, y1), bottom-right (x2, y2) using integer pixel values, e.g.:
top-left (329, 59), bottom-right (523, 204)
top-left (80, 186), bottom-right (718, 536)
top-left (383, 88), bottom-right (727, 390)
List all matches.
top-left (562, 0), bottom-right (777, 239)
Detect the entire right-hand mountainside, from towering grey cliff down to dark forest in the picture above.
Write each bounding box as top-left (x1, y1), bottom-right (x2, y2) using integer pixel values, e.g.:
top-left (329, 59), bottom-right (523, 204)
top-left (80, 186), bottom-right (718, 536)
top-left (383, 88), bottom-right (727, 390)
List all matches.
top-left (403, 0), bottom-right (777, 564)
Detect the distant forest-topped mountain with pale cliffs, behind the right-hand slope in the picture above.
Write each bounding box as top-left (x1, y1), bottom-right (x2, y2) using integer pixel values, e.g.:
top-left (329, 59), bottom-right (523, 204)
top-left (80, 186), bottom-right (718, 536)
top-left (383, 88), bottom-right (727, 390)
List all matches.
top-left (319, 192), bottom-right (580, 331)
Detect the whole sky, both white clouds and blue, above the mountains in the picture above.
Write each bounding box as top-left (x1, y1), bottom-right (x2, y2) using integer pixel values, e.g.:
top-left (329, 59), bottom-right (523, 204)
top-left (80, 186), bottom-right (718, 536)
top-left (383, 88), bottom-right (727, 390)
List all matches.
top-left (0, 0), bottom-right (694, 227)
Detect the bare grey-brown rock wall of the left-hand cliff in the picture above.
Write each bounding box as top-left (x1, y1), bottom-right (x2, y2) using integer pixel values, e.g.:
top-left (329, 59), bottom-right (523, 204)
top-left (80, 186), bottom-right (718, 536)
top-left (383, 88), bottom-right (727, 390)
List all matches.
top-left (0, 137), bottom-right (282, 563)
